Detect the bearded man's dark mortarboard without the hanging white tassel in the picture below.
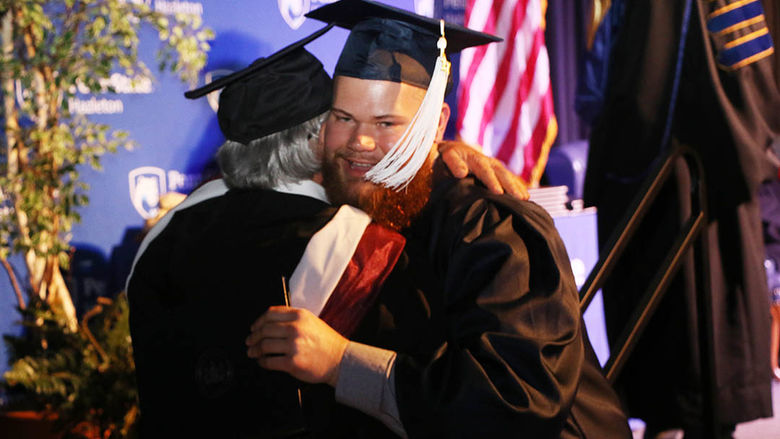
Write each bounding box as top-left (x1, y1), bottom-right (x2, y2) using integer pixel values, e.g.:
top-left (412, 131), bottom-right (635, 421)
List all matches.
top-left (306, 0), bottom-right (501, 88)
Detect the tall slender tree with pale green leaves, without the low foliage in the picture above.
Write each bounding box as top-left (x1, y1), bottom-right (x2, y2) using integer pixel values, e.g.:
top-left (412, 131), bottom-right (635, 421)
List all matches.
top-left (0, 0), bottom-right (213, 330)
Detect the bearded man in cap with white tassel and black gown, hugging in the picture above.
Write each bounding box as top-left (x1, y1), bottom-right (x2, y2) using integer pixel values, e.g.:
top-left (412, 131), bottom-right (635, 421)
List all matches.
top-left (246, 0), bottom-right (631, 438)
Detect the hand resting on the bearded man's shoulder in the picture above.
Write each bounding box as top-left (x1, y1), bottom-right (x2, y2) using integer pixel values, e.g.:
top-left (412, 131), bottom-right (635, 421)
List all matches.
top-left (438, 140), bottom-right (530, 200)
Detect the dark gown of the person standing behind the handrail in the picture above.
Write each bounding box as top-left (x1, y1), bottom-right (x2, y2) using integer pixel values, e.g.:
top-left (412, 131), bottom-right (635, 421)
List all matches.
top-left (585, 0), bottom-right (780, 430)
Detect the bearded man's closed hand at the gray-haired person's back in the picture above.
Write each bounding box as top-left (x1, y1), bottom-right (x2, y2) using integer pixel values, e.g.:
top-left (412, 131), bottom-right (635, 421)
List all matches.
top-left (246, 306), bottom-right (349, 387)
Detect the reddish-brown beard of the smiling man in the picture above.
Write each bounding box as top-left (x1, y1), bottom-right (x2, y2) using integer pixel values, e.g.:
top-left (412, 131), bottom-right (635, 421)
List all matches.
top-left (322, 157), bottom-right (433, 231)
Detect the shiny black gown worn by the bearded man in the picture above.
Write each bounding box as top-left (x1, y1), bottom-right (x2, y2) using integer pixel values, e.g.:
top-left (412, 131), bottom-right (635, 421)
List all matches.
top-left (350, 179), bottom-right (631, 438)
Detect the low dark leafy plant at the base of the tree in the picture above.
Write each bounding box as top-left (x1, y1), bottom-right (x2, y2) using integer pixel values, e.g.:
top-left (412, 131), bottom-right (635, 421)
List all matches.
top-left (4, 294), bottom-right (138, 438)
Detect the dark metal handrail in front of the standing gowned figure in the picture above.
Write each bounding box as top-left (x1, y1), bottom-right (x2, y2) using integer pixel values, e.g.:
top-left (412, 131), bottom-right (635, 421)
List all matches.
top-left (580, 146), bottom-right (718, 437)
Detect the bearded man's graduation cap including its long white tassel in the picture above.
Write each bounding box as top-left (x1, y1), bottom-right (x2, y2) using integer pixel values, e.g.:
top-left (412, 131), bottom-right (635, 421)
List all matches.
top-left (306, 0), bottom-right (501, 190)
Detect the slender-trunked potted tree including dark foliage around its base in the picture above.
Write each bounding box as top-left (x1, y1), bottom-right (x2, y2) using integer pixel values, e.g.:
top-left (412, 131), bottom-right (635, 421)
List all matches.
top-left (0, 0), bottom-right (213, 436)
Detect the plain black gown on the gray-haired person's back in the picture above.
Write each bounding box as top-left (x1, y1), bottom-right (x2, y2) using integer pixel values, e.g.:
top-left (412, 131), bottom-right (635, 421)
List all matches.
top-left (128, 190), bottom-right (342, 438)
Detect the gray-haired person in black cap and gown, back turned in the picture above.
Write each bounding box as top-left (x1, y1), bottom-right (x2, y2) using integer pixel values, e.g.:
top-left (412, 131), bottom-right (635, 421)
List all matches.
top-left (127, 43), bottom-right (372, 437)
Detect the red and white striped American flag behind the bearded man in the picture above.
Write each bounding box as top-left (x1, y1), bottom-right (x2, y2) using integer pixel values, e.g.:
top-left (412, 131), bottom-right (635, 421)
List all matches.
top-left (456, 0), bottom-right (558, 186)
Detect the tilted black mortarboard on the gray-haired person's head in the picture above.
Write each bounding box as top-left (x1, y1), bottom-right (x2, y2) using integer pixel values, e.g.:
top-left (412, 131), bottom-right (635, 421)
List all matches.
top-left (184, 25), bottom-right (333, 144)
